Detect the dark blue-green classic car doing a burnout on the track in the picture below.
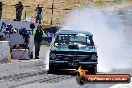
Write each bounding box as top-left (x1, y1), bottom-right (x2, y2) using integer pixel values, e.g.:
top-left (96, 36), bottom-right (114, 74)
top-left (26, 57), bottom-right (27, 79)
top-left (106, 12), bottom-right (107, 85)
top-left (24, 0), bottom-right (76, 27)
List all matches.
top-left (49, 30), bottom-right (98, 74)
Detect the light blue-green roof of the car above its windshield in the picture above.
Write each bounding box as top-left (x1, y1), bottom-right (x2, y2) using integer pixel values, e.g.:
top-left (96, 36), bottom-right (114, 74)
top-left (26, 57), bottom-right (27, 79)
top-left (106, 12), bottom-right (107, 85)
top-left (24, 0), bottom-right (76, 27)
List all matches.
top-left (56, 29), bottom-right (93, 36)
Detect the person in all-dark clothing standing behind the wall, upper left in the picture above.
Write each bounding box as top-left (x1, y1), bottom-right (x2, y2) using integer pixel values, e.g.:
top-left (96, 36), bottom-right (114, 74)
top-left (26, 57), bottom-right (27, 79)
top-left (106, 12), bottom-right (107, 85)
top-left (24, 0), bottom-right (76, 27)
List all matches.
top-left (15, 2), bottom-right (23, 21)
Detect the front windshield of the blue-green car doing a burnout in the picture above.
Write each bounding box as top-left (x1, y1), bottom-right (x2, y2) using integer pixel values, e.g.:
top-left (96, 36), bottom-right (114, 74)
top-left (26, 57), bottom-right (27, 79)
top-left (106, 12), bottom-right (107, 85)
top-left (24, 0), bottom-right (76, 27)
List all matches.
top-left (54, 34), bottom-right (94, 45)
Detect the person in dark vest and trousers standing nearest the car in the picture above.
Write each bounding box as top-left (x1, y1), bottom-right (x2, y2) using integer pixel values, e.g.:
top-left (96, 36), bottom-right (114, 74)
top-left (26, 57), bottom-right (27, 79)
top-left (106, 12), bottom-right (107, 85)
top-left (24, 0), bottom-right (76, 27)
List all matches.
top-left (33, 25), bottom-right (45, 59)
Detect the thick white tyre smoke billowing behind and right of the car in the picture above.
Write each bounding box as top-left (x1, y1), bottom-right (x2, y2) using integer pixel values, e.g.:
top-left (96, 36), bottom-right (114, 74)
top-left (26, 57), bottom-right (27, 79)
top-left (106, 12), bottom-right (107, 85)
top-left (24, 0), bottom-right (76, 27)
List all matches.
top-left (62, 8), bottom-right (132, 72)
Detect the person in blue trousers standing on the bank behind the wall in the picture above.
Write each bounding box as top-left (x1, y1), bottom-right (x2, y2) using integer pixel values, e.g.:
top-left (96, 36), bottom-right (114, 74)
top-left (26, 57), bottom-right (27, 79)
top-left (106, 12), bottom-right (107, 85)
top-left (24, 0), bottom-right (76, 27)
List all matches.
top-left (35, 4), bottom-right (42, 24)
